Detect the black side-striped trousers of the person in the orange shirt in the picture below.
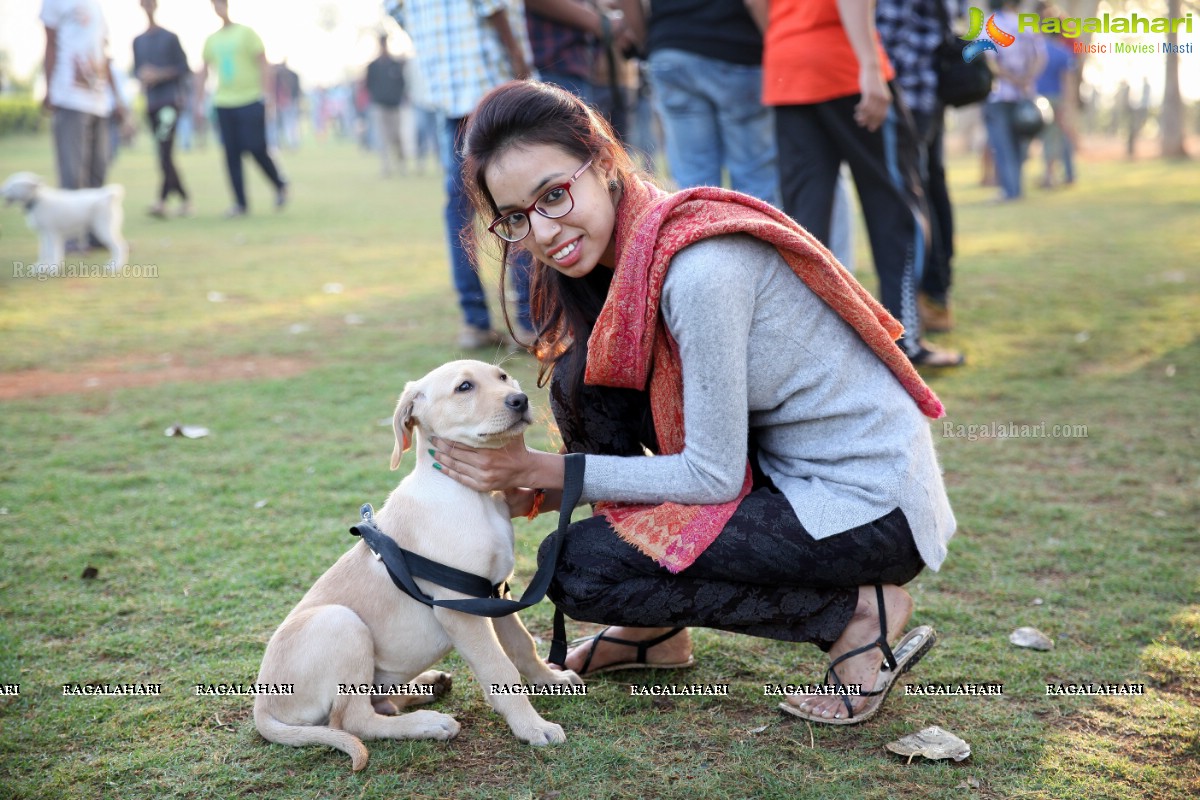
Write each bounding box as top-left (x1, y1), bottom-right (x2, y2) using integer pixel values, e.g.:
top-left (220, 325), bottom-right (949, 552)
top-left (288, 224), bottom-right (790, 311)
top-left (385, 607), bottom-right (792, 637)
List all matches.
top-left (775, 90), bottom-right (929, 355)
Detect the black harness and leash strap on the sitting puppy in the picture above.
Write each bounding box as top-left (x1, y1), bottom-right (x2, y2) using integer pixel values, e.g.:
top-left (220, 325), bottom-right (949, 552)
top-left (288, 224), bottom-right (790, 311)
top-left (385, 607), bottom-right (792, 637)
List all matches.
top-left (350, 453), bottom-right (583, 664)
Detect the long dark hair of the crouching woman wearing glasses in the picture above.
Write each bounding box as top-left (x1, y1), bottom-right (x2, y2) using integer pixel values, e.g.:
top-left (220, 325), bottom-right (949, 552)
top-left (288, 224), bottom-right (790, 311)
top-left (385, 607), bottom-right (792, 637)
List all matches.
top-left (462, 80), bottom-right (637, 409)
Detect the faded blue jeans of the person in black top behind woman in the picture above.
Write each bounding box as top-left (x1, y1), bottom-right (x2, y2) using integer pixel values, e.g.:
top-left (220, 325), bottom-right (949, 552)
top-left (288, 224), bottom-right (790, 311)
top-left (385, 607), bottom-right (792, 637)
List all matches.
top-left (648, 49), bottom-right (780, 206)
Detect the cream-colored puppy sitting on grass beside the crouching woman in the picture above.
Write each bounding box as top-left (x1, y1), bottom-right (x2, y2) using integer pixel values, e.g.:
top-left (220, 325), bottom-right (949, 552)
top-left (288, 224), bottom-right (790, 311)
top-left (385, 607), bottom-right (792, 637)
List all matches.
top-left (254, 361), bottom-right (583, 770)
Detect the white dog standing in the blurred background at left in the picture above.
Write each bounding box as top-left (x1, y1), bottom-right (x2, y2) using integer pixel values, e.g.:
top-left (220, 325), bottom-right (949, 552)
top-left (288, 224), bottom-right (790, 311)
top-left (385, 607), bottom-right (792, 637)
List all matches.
top-left (0, 173), bottom-right (130, 272)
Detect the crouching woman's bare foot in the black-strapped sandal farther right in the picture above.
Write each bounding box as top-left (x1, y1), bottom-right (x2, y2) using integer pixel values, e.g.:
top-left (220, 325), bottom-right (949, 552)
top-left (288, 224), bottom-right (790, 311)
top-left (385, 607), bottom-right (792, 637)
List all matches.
top-left (787, 585), bottom-right (912, 720)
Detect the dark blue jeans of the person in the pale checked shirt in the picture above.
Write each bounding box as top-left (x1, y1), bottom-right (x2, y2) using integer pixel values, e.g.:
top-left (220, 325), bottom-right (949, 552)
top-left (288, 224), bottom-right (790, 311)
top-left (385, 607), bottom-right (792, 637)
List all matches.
top-left (439, 118), bottom-right (533, 330)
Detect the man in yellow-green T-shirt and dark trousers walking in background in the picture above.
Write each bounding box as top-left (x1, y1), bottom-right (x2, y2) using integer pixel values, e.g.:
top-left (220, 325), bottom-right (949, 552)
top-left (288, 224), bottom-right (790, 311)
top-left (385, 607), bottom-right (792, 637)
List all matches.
top-left (197, 0), bottom-right (288, 218)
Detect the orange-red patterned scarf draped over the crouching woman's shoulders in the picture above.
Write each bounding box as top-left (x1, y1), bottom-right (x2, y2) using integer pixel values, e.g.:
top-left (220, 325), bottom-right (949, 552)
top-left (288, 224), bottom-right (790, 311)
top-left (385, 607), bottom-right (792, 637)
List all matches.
top-left (583, 179), bottom-right (944, 572)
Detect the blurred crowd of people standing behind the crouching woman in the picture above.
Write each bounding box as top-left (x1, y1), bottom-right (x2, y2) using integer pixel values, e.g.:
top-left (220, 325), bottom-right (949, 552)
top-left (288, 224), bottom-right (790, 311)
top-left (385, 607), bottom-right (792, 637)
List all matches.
top-left (41, 0), bottom-right (1171, 366)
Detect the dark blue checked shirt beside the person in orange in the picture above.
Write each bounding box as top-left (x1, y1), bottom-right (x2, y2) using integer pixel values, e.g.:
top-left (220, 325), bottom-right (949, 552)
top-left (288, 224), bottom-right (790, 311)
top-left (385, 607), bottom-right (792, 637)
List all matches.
top-left (875, 0), bottom-right (947, 114)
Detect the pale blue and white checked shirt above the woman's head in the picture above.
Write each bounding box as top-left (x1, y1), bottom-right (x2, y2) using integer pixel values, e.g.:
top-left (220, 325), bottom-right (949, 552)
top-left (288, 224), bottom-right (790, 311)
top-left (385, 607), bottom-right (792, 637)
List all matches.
top-left (385, 0), bottom-right (533, 119)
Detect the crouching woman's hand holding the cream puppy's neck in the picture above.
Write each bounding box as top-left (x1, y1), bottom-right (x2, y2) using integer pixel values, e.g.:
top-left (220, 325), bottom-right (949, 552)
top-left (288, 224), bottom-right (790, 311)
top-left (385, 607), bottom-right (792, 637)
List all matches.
top-left (430, 437), bottom-right (563, 496)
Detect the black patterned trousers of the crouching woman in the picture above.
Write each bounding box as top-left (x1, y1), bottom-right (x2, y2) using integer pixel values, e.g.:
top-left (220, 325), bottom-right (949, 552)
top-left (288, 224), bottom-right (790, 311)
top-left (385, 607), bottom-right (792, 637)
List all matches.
top-left (538, 381), bottom-right (924, 650)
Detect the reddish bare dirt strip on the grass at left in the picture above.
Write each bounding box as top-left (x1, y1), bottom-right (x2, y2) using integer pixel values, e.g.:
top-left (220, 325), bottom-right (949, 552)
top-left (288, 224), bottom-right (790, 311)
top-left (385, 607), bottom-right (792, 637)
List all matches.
top-left (0, 356), bottom-right (312, 402)
